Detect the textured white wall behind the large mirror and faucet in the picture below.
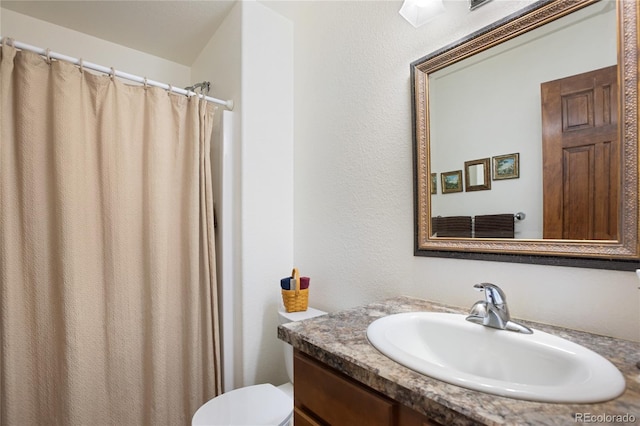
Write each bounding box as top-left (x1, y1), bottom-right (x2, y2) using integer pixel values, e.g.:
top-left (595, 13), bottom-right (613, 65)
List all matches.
top-left (286, 0), bottom-right (640, 340)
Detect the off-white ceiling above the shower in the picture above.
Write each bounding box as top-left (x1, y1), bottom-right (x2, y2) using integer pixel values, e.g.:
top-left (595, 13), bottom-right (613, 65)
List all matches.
top-left (0, 0), bottom-right (237, 66)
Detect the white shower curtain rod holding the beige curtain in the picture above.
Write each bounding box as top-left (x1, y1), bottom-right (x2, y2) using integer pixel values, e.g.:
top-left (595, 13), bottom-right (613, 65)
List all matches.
top-left (0, 37), bottom-right (233, 111)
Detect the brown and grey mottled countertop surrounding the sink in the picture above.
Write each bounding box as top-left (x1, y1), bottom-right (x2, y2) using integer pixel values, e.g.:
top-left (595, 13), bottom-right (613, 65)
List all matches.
top-left (278, 296), bottom-right (640, 426)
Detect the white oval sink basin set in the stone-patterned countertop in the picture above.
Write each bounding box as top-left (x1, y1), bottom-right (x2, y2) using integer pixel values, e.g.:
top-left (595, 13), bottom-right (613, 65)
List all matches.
top-left (367, 312), bottom-right (625, 403)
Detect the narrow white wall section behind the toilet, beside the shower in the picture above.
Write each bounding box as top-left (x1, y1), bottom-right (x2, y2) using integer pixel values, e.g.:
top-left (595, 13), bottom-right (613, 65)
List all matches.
top-left (240, 1), bottom-right (294, 385)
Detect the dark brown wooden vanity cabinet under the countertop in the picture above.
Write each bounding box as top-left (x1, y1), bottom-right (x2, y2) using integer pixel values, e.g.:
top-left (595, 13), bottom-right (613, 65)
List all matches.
top-left (293, 350), bottom-right (438, 426)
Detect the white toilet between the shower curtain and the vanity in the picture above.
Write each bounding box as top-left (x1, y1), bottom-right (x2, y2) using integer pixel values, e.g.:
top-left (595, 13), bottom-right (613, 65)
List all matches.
top-left (191, 306), bottom-right (326, 426)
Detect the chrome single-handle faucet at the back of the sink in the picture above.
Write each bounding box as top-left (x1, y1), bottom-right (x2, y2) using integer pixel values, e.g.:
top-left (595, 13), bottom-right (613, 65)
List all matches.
top-left (466, 283), bottom-right (533, 334)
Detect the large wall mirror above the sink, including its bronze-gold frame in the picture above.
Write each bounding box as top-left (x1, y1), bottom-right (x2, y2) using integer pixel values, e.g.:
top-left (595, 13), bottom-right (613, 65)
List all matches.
top-left (411, 0), bottom-right (640, 270)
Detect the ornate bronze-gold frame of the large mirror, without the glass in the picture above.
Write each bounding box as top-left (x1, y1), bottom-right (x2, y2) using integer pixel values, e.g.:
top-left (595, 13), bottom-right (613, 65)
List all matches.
top-left (411, 0), bottom-right (640, 270)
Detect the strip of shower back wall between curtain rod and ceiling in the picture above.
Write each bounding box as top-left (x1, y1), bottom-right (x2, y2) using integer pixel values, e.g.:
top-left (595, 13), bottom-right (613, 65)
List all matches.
top-left (2, 9), bottom-right (191, 87)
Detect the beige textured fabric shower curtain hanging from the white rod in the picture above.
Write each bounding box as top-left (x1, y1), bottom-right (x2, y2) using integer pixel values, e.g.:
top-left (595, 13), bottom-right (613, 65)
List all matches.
top-left (0, 45), bottom-right (220, 426)
